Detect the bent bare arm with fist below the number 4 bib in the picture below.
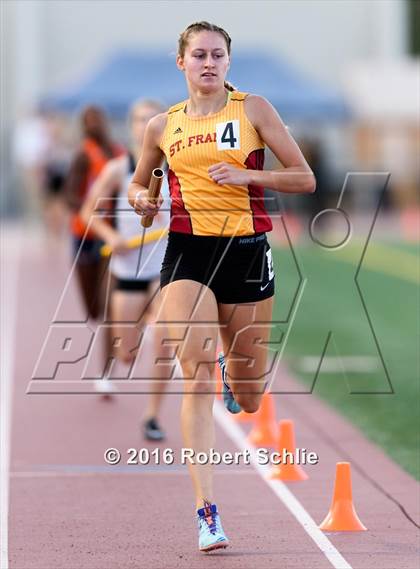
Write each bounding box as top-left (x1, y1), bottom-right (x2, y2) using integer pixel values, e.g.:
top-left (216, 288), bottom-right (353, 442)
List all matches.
top-left (209, 95), bottom-right (316, 193)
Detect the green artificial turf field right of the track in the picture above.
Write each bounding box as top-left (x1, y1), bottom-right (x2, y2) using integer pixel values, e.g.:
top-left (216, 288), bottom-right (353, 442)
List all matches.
top-left (272, 243), bottom-right (420, 479)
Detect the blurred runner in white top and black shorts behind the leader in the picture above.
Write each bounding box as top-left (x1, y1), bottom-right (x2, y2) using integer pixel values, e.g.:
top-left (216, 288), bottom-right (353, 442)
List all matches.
top-left (81, 100), bottom-right (169, 440)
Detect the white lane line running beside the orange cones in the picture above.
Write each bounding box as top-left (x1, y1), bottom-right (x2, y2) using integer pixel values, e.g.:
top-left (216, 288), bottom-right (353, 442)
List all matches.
top-left (214, 401), bottom-right (352, 569)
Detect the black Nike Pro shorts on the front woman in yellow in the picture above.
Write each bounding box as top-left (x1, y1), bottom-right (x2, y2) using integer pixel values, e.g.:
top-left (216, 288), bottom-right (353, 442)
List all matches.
top-left (160, 232), bottom-right (274, 304)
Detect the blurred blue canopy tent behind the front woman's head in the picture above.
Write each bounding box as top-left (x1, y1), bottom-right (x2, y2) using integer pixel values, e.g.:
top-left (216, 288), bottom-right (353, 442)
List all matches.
top-left (41, 50), bottom-right (349, 121)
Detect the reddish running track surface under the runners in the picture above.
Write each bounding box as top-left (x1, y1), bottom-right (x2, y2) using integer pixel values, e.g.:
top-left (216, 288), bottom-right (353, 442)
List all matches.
top-left (4, 225), bottom-right (419, 569)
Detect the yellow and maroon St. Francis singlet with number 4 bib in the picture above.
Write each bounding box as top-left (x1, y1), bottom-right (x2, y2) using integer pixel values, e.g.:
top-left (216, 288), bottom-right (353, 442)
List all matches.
top-left (160, 91), bottom-right (272, 236)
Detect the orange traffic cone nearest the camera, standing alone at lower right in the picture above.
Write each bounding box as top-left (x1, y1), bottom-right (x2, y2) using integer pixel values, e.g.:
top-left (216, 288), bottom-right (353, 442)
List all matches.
top-left (319, 462), bottom-right (367, 531)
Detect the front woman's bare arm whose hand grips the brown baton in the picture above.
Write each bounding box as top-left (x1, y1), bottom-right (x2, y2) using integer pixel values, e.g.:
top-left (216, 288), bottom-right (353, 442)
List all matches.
top-left (128, 113), bottom-right (167, 216)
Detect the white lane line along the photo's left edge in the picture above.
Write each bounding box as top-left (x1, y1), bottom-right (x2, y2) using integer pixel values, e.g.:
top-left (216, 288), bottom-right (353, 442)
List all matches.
top-left (0, 226), bottom-right (21, 569)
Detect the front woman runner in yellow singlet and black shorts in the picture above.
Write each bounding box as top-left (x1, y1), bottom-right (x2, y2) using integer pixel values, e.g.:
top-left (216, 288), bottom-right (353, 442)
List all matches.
top-left (129, 22), bottom-right (315, 551)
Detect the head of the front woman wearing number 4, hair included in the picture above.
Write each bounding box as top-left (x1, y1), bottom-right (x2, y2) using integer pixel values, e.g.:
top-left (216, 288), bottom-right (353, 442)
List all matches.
top-left (177, 22), bottom-right (235, 93)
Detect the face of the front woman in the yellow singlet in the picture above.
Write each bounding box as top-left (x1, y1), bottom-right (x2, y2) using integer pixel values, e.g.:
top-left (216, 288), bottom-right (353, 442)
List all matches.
top-left (177, 31), bottom-right (230, 93)
